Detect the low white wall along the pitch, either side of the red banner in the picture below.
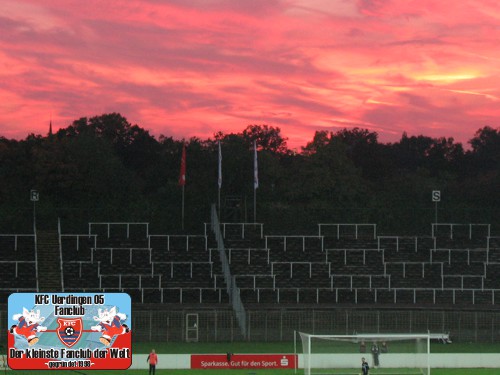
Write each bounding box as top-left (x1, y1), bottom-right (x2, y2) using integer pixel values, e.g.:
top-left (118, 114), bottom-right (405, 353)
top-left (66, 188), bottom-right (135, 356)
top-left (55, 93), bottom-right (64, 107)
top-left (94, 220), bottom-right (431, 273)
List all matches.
top-left (130, 353), bottom-right (500, 369)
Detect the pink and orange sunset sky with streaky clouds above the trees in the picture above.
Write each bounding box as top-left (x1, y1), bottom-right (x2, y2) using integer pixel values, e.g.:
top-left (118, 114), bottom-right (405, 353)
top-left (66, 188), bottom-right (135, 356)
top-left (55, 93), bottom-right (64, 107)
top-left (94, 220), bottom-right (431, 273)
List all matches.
top-left (0, 0), bottom-right (500, 148)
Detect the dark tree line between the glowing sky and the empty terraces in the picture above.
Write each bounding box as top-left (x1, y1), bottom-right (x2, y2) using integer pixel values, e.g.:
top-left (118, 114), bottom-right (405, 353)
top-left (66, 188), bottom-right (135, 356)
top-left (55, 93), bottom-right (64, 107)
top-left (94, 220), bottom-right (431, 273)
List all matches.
top-left (0, 113), bottom-right (500, 234)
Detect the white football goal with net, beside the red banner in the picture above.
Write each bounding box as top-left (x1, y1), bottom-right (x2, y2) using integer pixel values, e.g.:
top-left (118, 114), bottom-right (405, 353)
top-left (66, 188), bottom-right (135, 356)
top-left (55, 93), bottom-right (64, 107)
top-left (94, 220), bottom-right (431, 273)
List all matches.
top-left (299, 332), bottom-right (430, 375)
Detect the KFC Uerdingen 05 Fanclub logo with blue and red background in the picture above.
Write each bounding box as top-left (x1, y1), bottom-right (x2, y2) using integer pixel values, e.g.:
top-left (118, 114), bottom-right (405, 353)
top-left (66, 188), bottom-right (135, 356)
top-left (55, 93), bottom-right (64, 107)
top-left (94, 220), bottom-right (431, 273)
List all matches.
top-left (7, 293), bottom-right (133, 372)
